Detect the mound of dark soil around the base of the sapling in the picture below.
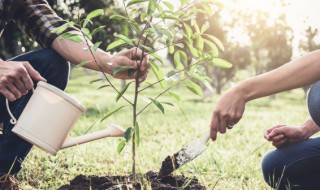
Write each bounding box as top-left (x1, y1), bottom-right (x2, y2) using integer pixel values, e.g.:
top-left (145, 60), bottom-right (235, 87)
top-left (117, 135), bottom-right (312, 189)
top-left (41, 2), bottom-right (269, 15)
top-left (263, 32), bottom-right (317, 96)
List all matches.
top-left (59, 171), bottom-right (206, 190)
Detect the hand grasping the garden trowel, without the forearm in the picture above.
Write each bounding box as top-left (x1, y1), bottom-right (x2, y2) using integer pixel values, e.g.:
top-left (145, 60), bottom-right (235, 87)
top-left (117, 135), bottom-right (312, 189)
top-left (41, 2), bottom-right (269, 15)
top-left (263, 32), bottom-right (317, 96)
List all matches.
top-left (210, 87), bottom-right (246, 141)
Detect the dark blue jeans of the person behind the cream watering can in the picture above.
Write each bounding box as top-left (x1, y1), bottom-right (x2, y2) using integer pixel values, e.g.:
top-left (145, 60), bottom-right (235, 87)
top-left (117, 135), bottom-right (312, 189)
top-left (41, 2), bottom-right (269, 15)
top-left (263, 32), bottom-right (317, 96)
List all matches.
top-left (0, 49), bottom-right (70, 174)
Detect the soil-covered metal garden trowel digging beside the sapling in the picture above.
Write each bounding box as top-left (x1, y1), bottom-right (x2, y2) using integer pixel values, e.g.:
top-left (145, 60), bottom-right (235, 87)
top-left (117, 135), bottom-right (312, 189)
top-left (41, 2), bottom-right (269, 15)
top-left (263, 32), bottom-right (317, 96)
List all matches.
top-left (159, 128), bottom-right (210, 176)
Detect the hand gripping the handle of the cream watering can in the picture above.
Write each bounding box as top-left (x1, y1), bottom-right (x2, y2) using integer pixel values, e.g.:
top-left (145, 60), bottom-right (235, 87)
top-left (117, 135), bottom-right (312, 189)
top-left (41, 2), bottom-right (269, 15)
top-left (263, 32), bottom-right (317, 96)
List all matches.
top-left (0, 61), bottom-right (46, 101)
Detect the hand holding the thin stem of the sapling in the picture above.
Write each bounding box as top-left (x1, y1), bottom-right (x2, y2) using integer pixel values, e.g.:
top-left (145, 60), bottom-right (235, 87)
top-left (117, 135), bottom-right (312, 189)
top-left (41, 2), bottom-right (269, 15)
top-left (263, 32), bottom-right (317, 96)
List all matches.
top-left (107, 48), bottom-right (149, 83)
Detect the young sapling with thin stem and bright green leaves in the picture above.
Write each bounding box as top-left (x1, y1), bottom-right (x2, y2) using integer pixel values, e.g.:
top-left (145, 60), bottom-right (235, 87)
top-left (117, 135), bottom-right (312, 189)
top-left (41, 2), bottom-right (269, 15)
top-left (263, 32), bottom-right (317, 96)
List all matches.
top-left (57, 0), bottom-right (232, 175)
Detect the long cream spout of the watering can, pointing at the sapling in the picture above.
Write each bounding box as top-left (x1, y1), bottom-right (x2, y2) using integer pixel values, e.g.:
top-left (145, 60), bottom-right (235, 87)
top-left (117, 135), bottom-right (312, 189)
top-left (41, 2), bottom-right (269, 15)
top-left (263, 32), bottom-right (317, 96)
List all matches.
top-left (61, 124), bottom-right (125, 149)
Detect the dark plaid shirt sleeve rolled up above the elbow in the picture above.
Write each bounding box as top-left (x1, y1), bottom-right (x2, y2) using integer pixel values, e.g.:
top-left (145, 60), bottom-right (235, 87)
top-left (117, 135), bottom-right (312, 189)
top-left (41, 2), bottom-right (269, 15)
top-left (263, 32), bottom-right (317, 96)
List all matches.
top-left (13, 0), bottom-right (77, 48)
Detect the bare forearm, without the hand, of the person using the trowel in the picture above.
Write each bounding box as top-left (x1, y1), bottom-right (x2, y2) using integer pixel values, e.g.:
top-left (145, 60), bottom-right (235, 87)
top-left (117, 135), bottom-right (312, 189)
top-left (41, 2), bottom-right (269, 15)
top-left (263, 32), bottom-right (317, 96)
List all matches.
top-left (237, 50), bottom-right (320, 101)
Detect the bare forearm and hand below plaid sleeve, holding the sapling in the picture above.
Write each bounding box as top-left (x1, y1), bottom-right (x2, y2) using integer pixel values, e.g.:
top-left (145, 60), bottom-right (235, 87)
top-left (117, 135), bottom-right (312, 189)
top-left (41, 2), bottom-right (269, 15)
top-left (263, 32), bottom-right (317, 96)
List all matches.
top-left (51, 31), bottom-right (149, 82)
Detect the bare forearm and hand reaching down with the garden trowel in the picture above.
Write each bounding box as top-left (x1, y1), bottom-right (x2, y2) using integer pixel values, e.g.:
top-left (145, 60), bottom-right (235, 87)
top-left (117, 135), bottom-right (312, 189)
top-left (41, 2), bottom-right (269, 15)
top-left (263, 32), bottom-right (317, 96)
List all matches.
top-left (211, 50), bottom-right (320, 140)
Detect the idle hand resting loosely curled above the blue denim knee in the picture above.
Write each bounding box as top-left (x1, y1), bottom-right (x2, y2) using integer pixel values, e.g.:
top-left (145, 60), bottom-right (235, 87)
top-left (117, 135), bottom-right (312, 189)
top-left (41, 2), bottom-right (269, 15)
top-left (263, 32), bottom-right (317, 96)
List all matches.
top-left (264, 125), bottom-right (309, 148)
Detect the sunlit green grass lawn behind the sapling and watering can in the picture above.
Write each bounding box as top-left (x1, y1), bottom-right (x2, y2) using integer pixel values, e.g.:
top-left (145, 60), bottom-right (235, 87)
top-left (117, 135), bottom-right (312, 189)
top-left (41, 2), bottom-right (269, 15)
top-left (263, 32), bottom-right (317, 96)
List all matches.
top-left (18, 71), bottom-right (308, 190)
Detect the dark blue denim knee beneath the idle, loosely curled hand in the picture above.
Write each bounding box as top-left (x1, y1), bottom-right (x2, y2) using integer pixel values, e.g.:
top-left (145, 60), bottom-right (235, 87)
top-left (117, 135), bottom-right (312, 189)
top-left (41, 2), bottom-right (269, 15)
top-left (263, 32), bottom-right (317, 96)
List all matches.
top-left (262, 137), bottom-right (320, 190)
